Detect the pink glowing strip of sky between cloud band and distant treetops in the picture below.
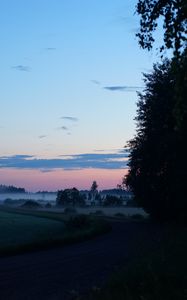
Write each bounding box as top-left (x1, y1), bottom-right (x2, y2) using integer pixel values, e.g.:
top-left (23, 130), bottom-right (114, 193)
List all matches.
top-left (0, 169), bottom-right (127, 192)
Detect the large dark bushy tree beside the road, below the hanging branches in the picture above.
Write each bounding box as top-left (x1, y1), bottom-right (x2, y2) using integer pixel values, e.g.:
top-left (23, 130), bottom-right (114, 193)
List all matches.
top-left (124, 53), bottom-right (187, 220)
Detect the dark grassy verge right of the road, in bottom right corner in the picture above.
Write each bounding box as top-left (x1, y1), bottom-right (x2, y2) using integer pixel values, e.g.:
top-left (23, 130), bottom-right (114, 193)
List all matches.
top-left (86, 225), bottom-right (187, 300)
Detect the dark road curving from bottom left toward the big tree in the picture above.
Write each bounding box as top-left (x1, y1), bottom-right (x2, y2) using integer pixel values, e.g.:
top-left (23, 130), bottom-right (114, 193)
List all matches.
top-left (0, 222), bottom-right (162, 300)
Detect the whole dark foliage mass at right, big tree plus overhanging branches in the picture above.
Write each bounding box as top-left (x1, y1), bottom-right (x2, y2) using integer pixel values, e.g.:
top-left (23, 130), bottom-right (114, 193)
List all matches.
top-left (123, 0), bottom-right (187, 222)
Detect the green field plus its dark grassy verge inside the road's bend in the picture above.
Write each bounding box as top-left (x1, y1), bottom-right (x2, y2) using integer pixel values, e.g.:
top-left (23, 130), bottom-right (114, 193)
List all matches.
top-left (0, 207), bottom-right (111, 256)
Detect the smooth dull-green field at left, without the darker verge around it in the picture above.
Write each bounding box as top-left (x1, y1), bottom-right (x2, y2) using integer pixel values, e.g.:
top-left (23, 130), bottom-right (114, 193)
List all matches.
top-left (0, 211), bottom-right (65, 253)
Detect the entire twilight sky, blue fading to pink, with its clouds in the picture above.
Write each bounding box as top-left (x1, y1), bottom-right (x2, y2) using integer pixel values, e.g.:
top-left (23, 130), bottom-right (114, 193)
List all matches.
top-left (0, 0), bottom-right (157, 191)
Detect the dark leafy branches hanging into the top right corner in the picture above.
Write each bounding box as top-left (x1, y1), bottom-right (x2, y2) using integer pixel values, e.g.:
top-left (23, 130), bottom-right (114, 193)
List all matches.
top-left (136, 0), bottom-right (187, 56)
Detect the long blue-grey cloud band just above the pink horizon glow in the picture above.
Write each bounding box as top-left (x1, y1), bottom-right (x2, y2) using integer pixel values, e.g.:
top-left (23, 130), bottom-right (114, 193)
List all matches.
top-left (0, 153), bottom-right (128, 172)
